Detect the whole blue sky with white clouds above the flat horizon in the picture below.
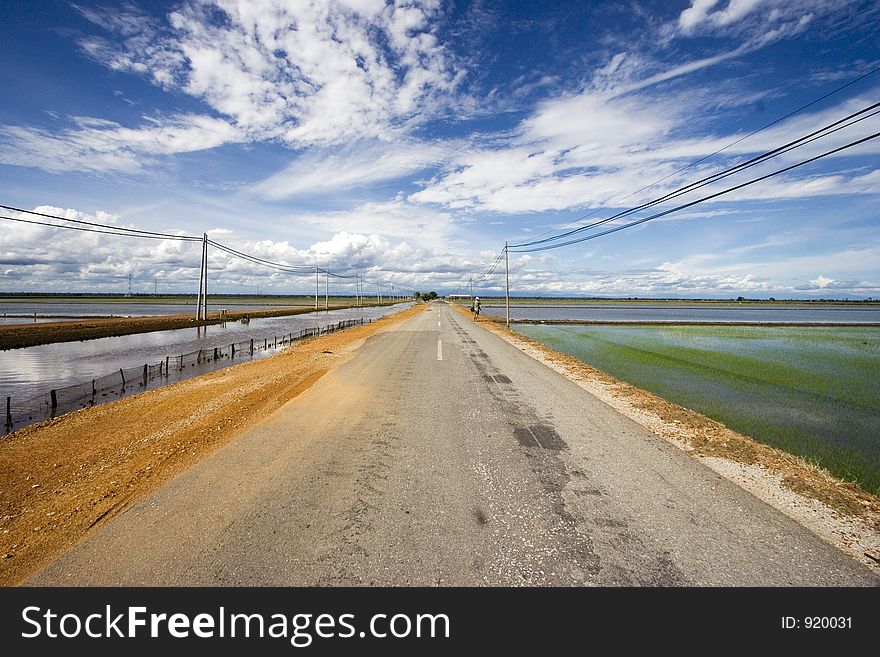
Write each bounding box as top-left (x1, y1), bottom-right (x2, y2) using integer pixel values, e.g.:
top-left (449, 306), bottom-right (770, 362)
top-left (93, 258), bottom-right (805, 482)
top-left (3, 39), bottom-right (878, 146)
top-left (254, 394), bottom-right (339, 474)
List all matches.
top-left (0, 0), bottom-right (880, 298)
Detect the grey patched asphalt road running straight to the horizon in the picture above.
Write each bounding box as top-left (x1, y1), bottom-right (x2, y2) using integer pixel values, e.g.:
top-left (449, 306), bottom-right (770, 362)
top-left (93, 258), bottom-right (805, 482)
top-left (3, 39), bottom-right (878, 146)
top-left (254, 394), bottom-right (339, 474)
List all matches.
top-left (29, 303), bottom-right (880, 586)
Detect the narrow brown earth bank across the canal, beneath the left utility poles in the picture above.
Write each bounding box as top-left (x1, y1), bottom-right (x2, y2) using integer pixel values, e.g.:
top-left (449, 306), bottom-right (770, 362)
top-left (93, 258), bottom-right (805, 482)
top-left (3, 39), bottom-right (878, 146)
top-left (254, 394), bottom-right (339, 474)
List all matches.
top-left (0, 305), bottom-right (392, 349)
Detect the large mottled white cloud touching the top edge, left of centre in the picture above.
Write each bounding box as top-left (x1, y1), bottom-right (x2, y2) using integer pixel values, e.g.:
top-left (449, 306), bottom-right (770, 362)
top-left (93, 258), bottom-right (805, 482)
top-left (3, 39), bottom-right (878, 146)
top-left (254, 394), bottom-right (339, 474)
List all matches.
top-left (82, 0), bottom-right (462, 147)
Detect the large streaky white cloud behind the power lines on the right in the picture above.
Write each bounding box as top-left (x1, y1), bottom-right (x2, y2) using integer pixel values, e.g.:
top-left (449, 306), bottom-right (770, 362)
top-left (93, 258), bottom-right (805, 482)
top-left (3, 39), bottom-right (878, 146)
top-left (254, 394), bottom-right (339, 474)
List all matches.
top-left (410, 66), bottom-right (880, 214)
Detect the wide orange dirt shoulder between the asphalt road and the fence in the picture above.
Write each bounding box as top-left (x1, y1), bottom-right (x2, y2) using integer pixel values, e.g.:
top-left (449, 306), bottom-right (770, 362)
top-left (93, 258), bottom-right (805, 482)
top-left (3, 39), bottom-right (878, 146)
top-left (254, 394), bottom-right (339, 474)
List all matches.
top-left (0, 305), bottom-right (425, 586)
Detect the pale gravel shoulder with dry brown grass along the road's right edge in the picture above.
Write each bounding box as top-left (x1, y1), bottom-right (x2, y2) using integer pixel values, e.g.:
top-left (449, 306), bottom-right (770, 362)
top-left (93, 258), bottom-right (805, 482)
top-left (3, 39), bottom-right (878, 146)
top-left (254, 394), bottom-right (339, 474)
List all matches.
top-left (468, 304), bottom-right (880, 573)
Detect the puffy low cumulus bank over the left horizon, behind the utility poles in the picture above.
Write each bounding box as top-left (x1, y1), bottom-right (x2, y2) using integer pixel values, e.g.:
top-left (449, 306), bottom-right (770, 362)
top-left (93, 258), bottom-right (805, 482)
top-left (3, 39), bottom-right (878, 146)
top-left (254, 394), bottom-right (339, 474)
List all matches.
top-left (0, 200), bottom-right (475, 293)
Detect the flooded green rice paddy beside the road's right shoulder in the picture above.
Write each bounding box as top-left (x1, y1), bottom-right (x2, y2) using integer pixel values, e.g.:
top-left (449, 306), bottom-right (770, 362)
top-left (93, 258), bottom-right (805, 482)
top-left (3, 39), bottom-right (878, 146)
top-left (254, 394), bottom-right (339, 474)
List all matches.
top-left (516, 324), bottom-right (880, 495)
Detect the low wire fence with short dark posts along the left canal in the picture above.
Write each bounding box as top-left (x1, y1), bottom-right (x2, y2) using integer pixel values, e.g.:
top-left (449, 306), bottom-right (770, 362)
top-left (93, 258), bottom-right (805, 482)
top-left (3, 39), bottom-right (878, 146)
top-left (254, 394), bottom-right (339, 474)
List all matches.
top-left (5, 318), bottom-right (371, 434)
